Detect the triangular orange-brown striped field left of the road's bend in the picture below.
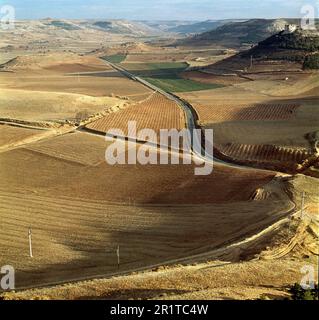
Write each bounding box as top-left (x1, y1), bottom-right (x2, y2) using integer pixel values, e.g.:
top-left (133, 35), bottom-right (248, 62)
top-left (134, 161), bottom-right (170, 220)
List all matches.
top-left (86, 93), bottom-right (185, 138)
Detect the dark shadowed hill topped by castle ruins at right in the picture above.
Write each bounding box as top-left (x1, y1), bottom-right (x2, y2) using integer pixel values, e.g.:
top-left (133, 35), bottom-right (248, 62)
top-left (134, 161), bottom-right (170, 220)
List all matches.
top-left (202, 29), bottom-right (319, 74)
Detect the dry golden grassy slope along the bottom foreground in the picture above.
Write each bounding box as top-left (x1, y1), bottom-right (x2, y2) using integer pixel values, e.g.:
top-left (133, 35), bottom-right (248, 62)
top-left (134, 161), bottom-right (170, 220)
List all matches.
top-left (1, 176), bottom-right (319, 300)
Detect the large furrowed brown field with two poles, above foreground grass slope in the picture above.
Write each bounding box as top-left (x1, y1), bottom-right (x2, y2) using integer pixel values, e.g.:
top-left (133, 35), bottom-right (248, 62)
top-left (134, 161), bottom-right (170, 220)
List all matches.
top-left (0, 185), bottom-right (292, 287)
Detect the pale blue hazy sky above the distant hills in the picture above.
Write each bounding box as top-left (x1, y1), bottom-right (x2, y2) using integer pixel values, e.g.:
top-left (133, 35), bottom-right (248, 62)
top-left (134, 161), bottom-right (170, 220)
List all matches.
top-left (0, 0), bottom-right (319, 20)
